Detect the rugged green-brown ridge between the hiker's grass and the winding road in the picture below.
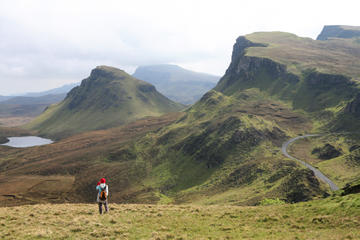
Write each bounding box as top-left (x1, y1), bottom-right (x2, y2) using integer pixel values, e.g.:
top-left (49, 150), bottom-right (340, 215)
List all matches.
top-left (0, 89), bottom-right (328, 205)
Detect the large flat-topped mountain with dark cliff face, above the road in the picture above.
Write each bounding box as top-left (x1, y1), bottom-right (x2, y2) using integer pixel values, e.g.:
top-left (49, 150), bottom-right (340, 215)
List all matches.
top-left (215, 32), bottom-right (360, 132)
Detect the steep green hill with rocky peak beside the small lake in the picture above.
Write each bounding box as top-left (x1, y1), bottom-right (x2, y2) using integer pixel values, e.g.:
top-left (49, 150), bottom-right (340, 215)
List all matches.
top-left (28, 66), bottom-right (184, 138)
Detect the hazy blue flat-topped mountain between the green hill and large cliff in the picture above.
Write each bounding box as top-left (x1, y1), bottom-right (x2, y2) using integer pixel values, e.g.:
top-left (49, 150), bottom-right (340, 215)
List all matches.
top-left (133, 64), bottom-right (220, 104)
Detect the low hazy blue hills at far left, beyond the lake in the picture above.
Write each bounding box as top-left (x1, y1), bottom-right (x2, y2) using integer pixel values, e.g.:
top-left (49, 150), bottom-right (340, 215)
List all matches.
top-left (0, 93), bottom-right (66, 117)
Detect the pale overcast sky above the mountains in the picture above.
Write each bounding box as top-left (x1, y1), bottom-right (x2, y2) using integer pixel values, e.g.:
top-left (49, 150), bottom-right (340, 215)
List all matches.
top-left (0, 0), bottom-right (360, 95)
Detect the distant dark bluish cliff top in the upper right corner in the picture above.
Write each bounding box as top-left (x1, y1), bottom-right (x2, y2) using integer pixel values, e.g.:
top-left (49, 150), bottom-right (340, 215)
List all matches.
top-left (316, 25), bottom-right (360, 40)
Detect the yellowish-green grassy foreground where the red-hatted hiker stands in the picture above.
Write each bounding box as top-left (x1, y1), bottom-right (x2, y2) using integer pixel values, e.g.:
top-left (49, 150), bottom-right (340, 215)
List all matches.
top-left (0, 194), bottom-right (360, 239)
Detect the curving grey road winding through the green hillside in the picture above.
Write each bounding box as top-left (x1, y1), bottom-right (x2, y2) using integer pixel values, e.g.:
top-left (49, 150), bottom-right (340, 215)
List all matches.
top-left (281, 134), bottom-right (339, 191)
